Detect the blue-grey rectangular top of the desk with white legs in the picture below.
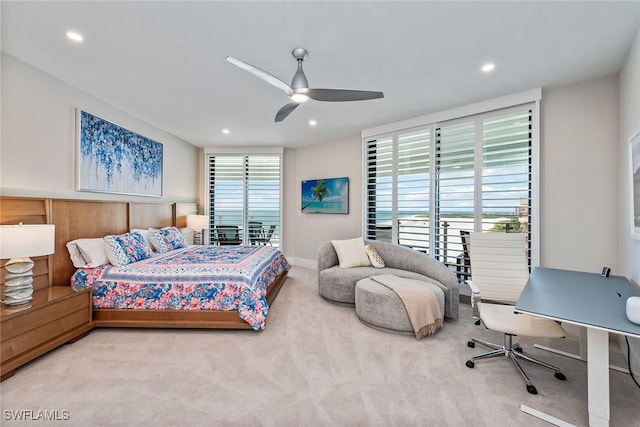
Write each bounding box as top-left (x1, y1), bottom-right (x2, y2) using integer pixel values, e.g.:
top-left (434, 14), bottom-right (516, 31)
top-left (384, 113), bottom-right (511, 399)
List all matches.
top-left (516, 267), bottom-right (640, 337)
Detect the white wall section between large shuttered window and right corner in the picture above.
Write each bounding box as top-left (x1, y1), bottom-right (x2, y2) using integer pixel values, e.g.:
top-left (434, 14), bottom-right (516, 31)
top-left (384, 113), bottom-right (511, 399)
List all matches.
top-left (540, 76), bottom-right (620, 274)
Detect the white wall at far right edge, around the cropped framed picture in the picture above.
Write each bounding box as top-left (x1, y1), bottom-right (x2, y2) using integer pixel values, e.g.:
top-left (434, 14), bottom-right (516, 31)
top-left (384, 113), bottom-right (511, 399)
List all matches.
top-left (617, 30), bottom-right (640, 380)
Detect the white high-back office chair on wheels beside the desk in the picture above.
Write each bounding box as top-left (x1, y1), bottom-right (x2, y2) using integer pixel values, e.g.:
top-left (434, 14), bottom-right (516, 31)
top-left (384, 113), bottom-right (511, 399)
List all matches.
top-left (466, 232), bottom-right (566, 394)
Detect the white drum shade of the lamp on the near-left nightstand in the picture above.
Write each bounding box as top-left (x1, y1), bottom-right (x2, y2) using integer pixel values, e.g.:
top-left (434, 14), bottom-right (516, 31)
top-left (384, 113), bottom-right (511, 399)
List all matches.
top-left (0, 224), bottom-right (55, 259)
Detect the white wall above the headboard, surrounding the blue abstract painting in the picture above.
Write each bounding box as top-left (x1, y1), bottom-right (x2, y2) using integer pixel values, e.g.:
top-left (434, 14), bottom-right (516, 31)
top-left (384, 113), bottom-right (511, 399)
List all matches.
top-left (0, 53), bottom-right (199, 202)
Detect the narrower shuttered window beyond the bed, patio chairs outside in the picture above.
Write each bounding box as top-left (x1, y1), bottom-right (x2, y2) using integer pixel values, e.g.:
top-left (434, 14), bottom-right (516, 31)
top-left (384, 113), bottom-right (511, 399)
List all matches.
top-left (207, 153), bottom-right (282, 247)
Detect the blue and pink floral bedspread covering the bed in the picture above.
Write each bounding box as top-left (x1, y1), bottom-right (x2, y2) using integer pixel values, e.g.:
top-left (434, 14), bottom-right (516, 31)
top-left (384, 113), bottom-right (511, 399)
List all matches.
top-left (71, 246), bottom-right (291, 330)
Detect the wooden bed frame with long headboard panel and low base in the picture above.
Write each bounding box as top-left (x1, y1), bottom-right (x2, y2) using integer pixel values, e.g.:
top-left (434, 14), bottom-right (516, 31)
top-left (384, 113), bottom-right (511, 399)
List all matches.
top-left (0, 197), bottom-right (287, 329)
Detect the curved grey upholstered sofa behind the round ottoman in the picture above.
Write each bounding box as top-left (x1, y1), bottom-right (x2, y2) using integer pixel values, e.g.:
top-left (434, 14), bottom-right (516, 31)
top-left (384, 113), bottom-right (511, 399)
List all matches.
top-left (318, 240), bottom-right (459, 319)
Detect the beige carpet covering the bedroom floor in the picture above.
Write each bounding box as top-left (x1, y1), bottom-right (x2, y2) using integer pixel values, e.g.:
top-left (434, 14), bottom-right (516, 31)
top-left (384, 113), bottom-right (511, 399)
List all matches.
top-left (0, 267), bottom-right (640, 426)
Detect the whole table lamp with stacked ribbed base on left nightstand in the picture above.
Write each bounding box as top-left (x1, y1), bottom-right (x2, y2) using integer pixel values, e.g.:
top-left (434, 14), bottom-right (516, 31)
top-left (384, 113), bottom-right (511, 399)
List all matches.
top-left (0, 223), bottom-right (55, 305)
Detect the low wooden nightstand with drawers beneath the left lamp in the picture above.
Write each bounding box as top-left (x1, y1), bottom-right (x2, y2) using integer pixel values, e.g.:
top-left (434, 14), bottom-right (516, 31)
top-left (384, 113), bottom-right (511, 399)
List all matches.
top-left (0, 286), bottom-right (94, 381)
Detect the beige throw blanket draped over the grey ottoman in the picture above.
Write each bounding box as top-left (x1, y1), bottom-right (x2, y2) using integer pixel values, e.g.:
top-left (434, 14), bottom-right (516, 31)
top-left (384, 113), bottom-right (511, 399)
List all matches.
top-left (371, 274), bottom-right (442, 340)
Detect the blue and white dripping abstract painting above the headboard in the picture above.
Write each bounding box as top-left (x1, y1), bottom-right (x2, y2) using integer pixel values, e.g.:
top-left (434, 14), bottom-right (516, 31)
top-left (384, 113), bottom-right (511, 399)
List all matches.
top-left (77, 110), bottom-right (163, 197)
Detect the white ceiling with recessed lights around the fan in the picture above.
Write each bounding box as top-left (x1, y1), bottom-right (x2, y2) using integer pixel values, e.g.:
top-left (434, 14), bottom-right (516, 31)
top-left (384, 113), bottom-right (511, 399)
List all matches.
top-left (2, 1), bottom-right (640, 147)
